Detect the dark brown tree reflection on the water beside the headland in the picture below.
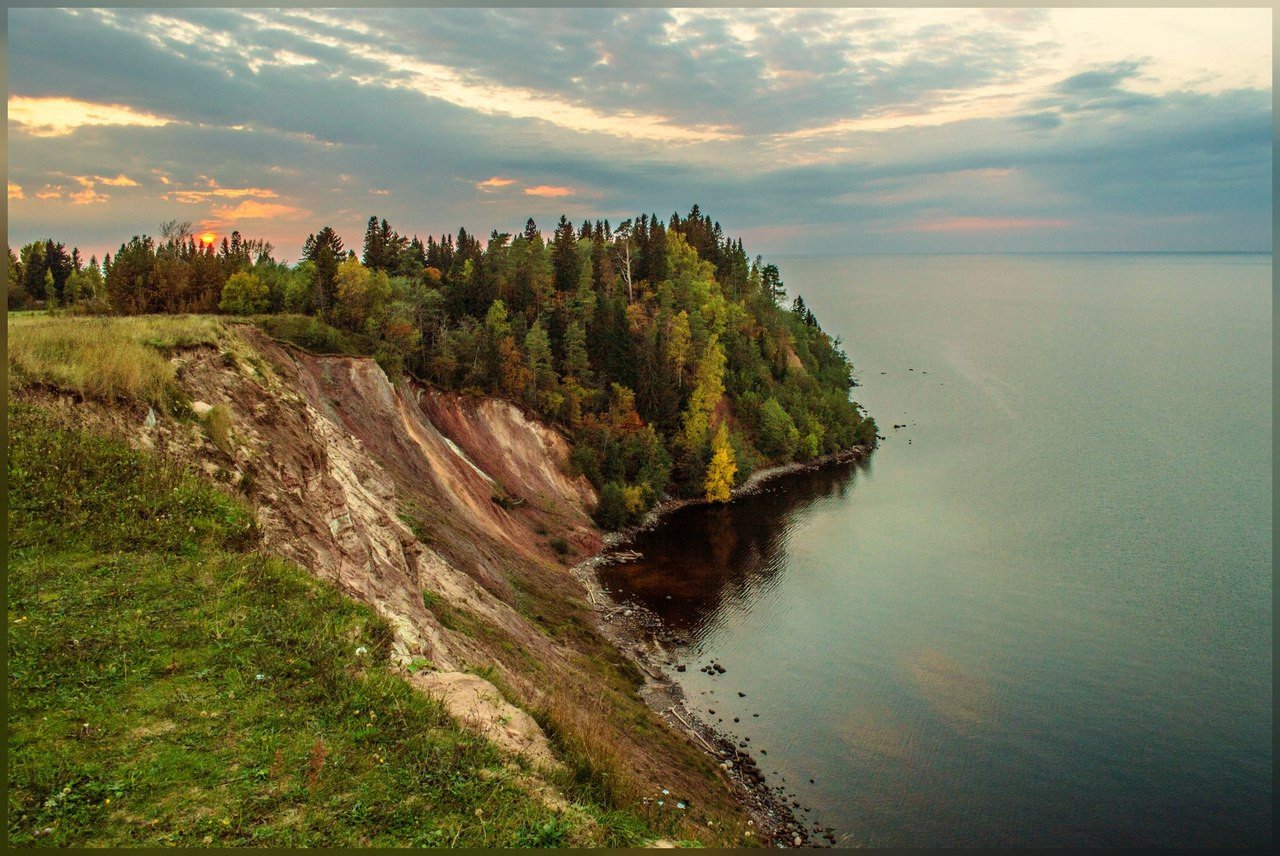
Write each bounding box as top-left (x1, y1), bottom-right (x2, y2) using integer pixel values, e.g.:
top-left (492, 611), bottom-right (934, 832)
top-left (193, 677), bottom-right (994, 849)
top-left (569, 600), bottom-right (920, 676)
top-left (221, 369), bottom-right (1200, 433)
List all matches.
top-left (600, 461), bottom-right (868, 636)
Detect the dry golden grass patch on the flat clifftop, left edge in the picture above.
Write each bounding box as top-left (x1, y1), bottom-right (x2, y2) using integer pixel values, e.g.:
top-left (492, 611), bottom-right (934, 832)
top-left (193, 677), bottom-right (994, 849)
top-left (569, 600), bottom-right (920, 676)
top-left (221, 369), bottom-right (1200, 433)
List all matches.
top-left (9, 315), bottom-right (223, 407)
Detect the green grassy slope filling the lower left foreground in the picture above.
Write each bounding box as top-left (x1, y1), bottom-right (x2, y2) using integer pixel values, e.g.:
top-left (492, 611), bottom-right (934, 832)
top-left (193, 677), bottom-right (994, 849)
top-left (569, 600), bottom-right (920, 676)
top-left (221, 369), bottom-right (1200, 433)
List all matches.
top-left (6, 406), bottom-right (655, 847)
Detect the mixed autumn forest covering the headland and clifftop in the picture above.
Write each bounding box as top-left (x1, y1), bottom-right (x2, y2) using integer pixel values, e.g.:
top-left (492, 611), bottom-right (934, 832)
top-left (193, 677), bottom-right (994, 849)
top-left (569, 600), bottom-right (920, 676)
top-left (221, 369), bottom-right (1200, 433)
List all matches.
top-left (8, 205), bottom-right (876, 528)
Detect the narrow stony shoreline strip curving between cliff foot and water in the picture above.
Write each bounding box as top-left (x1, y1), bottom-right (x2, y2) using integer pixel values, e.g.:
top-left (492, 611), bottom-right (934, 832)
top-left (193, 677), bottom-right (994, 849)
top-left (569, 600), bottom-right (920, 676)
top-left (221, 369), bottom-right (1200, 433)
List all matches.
top-left (571, 445), bottom-right (876, 847)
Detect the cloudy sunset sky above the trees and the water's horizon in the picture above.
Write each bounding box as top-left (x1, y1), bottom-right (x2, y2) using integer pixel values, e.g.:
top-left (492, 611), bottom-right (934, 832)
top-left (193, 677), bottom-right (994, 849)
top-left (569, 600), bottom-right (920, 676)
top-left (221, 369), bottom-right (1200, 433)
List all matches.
top-left (8, 8), bottom-right (1272, 261)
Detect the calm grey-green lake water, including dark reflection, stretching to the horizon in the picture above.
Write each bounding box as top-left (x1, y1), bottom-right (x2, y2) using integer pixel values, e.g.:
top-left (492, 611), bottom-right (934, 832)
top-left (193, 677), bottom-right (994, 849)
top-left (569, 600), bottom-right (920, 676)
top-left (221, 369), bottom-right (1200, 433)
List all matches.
top-left (602, 250), bottom-right (1272, 847)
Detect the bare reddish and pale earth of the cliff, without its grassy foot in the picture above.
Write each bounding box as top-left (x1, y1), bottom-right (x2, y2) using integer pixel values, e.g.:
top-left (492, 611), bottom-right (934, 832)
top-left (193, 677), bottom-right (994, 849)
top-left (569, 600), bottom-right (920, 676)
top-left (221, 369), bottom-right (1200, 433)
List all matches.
top-left (165, 326), bottom-right (599, 679)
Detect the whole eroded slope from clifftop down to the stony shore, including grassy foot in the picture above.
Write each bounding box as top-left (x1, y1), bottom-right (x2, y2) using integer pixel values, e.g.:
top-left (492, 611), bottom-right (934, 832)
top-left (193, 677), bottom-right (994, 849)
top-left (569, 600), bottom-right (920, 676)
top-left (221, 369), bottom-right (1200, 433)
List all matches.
top-left (26, 319), bottom-right (746, 838)
